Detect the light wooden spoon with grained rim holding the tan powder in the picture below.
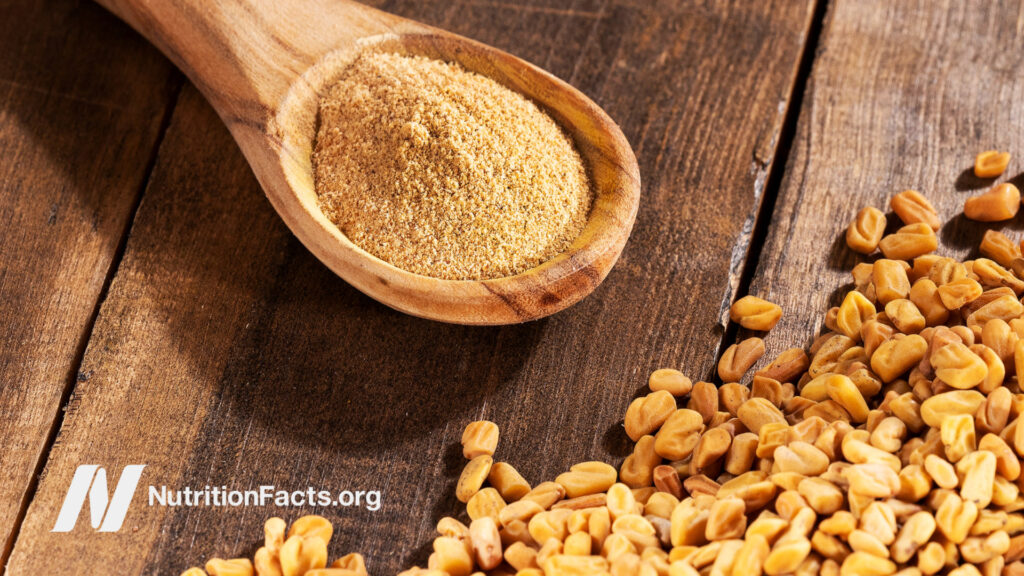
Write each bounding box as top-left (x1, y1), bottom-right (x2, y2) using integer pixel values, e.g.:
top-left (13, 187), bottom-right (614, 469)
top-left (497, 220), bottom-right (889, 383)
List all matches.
top-left (98, 0), bottom-right (640, 324)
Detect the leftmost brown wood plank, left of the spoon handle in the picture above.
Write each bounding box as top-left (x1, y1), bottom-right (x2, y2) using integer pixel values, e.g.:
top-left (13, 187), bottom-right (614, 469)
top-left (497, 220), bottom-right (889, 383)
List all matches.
top-left (0, 0), bottom-right (179, 566)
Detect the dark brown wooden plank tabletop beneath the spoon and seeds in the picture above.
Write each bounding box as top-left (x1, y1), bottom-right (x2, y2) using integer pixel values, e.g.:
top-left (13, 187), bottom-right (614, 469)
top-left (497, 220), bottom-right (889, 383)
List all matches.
top-left (0, 0), bottom-right (1024, 575)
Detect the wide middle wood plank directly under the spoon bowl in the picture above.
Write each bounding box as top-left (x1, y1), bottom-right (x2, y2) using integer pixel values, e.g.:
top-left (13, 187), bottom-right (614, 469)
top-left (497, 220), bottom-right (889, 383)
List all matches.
top-left (9, 0), bottom-right (812, 575)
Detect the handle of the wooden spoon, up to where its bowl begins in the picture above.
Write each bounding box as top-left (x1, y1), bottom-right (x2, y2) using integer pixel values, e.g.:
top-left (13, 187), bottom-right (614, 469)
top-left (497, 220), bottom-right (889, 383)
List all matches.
top-left (96, 0), bottom-right (412, 127)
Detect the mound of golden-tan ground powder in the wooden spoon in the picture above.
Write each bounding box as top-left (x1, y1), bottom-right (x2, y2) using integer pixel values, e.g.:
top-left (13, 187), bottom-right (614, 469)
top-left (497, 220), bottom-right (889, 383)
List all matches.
top-left (312, 53), bottom-right (593, 280)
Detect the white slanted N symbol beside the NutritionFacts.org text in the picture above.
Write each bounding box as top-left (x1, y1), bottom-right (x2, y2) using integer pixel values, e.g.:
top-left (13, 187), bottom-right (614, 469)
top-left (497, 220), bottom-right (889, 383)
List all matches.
top-left (51, 464), bottom-right (145, 532)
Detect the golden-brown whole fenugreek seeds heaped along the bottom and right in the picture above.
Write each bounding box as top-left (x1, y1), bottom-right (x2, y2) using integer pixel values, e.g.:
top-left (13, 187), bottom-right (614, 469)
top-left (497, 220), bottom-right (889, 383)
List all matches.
top-left (186, 153), bottom-right (1024, 576)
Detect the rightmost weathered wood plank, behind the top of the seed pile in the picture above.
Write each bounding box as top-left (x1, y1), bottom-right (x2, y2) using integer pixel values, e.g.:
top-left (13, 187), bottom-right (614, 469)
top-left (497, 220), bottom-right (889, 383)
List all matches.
top-left (751, 0), bottom-right (1024, 377)
